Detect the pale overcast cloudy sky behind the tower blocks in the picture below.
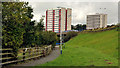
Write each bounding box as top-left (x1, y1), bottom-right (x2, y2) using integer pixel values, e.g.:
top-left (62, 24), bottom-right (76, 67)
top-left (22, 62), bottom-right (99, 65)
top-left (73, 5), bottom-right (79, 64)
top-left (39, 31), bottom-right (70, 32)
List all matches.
top-left (24, 0), bottom-right (118, 25)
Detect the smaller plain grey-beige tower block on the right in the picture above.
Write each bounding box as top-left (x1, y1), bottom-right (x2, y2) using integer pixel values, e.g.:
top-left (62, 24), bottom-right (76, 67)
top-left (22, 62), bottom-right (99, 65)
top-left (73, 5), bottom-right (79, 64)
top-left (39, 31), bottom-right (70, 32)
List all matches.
top-left (86, 14), bottom-right (107, 29)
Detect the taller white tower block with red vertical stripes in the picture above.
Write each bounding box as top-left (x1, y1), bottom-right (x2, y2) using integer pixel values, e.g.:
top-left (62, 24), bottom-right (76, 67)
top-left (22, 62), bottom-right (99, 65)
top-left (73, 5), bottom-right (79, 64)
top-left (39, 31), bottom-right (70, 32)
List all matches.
top-left (45, 7), bottom-right (72, 32)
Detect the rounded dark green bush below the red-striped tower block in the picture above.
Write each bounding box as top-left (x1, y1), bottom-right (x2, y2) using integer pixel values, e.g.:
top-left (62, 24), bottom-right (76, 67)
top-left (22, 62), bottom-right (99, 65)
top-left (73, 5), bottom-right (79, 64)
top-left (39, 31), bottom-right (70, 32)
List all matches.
top-left (34, 31), bottom-right (58, 47)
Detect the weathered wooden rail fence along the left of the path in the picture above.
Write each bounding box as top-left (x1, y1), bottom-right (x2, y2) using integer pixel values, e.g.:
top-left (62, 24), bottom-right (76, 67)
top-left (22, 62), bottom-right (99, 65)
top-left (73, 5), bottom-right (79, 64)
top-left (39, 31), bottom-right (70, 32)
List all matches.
top-left (0, 45), bottom-right (52, 65)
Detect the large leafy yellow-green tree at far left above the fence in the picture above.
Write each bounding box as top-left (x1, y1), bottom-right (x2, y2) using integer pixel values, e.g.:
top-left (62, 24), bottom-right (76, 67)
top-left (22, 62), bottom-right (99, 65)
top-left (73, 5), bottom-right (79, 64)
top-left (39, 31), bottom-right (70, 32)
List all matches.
top-left (2, 2), bottom-right (31, 56)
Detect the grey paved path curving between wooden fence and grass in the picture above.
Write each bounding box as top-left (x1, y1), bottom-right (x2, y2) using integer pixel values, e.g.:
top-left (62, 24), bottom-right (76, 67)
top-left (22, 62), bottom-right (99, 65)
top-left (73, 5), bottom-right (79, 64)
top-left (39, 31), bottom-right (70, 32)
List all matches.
top-left (13, 48), bottom-right (60, 66)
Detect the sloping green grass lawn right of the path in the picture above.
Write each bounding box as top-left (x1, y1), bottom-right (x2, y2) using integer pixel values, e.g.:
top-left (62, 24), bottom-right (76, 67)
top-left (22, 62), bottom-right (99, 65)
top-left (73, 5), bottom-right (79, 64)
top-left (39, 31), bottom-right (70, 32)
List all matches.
top-left (36, 30), bottom-right (118, 67)
